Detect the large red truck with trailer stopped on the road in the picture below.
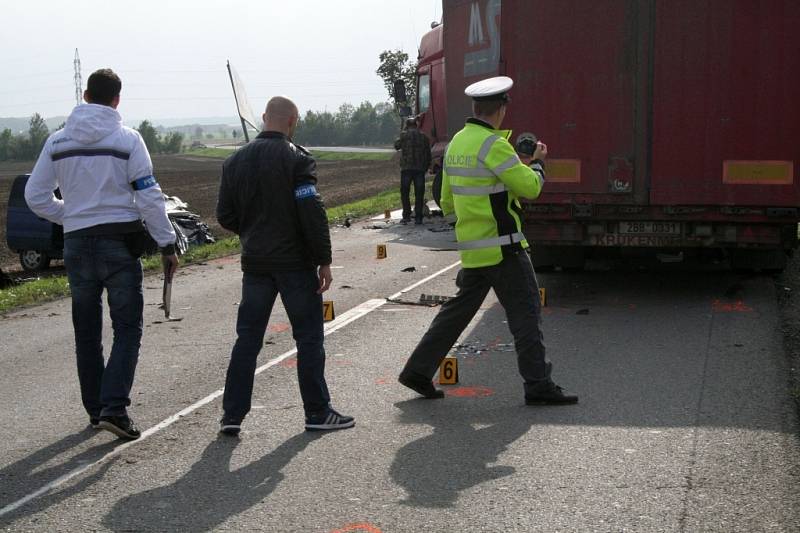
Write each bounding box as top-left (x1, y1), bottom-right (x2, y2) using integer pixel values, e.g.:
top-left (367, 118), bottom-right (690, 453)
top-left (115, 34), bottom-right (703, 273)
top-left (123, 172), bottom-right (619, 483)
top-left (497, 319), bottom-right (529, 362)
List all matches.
top-left (417, 0), bottom-right (800, 269)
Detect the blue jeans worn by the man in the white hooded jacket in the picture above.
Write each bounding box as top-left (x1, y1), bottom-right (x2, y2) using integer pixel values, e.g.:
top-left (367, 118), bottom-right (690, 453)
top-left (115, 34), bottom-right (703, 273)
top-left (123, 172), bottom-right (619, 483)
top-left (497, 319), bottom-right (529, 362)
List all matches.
top-left (64, 237), bottom-right (144, 417)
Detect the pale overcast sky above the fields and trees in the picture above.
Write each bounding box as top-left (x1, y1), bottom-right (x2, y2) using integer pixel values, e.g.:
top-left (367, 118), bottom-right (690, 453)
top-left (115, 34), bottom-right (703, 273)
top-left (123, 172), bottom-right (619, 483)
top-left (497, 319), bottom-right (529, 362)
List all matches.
top-left (0, 0), bottom-right (441, 121)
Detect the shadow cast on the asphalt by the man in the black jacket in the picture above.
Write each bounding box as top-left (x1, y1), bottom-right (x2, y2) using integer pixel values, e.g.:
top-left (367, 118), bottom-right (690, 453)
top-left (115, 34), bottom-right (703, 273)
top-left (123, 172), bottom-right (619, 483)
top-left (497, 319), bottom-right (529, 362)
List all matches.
top-left (103, 432), bottom-right (321, 531)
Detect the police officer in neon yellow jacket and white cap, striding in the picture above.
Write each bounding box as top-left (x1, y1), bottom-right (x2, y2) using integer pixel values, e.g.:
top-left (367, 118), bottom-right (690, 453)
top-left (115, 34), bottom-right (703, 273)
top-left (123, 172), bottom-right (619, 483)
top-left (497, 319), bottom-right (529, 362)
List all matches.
top-left (398, 72), bottom-right (578, 405)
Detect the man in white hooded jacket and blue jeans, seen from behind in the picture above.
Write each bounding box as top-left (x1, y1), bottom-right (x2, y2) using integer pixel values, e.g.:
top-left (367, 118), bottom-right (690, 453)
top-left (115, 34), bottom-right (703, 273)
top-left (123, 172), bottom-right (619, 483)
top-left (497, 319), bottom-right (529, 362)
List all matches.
top-left (25, 69), bottom-right (178, 440)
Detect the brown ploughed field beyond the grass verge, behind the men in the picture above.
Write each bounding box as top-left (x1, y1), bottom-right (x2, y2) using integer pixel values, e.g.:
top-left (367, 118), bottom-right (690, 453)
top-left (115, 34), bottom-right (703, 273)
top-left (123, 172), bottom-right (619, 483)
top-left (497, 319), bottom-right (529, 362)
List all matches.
top-left (0, 154), bottom-right (400, 273)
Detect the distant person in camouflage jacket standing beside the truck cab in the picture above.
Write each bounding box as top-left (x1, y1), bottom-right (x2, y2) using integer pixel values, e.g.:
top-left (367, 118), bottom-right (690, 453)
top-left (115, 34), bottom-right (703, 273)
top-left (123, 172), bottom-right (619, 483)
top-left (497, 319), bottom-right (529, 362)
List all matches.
top-left (394, 117), bottom-right (431, 224)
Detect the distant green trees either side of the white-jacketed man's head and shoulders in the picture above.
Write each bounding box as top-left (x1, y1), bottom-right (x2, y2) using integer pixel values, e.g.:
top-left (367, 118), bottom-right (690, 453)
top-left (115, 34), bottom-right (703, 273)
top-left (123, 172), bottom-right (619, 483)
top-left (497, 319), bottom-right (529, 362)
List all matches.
top-left (0, 117), bottom-right (183, 161)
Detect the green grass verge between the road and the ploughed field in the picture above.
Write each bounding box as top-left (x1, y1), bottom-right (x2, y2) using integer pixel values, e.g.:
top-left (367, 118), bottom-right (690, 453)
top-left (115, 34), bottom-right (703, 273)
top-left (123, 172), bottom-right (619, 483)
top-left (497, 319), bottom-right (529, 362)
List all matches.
top-left (0, 183), bottom-right (431, 314)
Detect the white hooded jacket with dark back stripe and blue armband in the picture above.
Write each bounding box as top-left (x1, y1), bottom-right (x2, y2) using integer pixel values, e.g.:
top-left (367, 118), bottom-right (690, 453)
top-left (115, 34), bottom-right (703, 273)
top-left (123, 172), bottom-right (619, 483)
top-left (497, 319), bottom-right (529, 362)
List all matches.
top-left (25, 104), bottom-right (175, 247)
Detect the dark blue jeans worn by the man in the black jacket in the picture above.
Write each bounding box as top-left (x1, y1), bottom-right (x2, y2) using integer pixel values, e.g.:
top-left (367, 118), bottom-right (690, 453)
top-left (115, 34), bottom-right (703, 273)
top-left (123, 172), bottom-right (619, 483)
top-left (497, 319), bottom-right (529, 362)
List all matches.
top-left (222, 270), bottom-right (331, 421)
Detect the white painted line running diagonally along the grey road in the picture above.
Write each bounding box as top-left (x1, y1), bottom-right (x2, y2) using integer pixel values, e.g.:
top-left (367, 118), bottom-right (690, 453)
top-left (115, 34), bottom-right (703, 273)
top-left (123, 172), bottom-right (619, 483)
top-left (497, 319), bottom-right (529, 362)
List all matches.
top-left (0, 261), bottom-right (461, 516)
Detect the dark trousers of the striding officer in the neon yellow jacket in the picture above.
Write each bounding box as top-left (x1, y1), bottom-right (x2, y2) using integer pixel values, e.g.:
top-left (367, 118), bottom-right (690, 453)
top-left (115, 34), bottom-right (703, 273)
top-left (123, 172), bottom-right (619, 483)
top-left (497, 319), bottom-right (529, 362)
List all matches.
top-left (403, 251), bottom-right (551, 391)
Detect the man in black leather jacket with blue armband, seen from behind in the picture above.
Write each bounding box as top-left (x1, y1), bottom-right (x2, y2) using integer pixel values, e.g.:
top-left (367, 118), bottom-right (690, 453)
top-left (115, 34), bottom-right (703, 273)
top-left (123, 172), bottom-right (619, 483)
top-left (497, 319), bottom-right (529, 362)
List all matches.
top-left (217, 96), bottom-right (355, 435)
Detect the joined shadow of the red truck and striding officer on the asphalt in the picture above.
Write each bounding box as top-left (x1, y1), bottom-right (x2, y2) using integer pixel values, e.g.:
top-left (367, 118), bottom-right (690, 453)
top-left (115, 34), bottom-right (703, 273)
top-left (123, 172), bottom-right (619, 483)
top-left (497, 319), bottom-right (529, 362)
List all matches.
top-left (390, 266), bottom-right (797, 508)
